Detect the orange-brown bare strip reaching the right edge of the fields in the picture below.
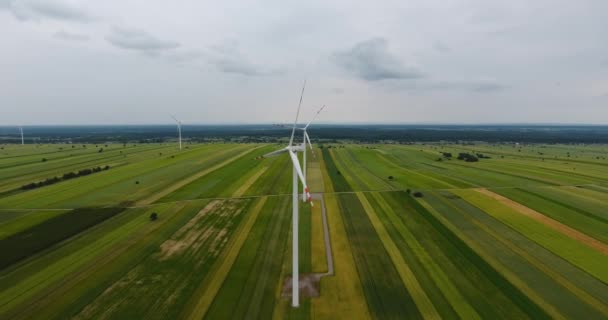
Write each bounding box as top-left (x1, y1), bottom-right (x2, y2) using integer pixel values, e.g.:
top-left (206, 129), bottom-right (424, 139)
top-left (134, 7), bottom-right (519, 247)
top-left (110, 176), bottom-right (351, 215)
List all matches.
top-left (474, 189), bottom-right (608, 255)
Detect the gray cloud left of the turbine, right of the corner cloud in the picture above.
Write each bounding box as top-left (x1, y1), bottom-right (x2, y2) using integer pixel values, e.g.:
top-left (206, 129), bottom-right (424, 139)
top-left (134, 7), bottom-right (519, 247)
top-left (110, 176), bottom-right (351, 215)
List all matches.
top-left (106, 27), bottom-right (180, 55)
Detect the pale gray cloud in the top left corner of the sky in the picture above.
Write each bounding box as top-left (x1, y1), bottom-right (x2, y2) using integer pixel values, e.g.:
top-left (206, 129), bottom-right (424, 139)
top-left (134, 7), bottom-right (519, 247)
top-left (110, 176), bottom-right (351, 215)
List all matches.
top-left (0, 0), bottom-right (95, 22)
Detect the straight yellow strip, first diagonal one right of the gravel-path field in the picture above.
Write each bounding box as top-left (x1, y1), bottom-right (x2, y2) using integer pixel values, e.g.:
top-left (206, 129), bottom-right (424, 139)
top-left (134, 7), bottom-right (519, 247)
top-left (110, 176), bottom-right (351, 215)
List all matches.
top-left (357, 192), bottom-right (441, 319)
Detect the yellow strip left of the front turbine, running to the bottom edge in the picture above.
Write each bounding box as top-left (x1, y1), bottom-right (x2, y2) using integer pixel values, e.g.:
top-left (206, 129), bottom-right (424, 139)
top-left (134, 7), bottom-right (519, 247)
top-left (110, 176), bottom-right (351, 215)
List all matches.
top-left (188, 197), bottom-right (268, 319)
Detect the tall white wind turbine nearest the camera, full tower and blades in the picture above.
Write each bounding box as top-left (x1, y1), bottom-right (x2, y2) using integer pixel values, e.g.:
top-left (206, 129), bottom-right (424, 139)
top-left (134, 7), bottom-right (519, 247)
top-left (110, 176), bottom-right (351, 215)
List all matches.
top-left (264, 81), bottom-right (313, 308)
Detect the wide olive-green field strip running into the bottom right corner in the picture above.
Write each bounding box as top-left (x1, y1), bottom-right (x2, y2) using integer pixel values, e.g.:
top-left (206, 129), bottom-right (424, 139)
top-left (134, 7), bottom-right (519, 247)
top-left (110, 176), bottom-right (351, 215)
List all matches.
top-left (426, 193), bottom-right (608, 319)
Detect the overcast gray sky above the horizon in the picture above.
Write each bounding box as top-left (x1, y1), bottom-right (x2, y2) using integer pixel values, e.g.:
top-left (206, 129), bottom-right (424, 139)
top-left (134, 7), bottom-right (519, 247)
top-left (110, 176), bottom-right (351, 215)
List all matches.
top-left (0, 0), bottom-right (608, 125)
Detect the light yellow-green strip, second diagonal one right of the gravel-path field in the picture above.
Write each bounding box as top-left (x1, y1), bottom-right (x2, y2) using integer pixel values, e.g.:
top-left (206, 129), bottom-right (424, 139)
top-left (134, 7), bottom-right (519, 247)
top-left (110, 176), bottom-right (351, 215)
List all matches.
top-left (372, 193), bottom-right (481, 320)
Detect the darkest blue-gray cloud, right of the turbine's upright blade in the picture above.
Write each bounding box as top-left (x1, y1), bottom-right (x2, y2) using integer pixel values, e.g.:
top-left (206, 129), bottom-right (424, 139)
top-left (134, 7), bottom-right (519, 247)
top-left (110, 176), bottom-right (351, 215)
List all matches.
top-left (332, 38), bottom-right (424, 81)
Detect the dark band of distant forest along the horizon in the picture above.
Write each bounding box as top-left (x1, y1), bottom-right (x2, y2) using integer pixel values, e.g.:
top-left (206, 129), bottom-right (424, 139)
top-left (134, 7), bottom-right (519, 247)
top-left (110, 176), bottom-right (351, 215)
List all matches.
top-left (0, 125), bottom-right (608, 144)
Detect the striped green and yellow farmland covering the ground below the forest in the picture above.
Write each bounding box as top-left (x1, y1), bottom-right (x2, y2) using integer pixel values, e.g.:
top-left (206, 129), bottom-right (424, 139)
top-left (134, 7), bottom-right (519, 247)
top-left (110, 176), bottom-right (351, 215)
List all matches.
top-left (0, 143), bottom-right (608, 319)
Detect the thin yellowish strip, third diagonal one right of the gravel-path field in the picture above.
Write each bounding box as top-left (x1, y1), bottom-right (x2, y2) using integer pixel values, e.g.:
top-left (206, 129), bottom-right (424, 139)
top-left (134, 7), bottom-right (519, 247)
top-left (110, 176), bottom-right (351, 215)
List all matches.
top-left (418, 199), bottom-right (566, 320)
